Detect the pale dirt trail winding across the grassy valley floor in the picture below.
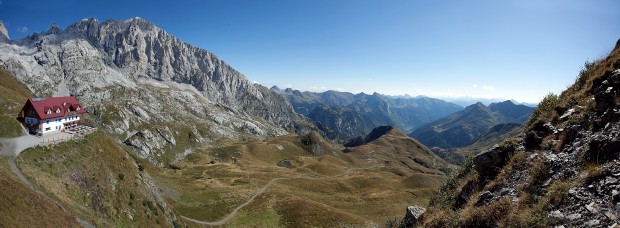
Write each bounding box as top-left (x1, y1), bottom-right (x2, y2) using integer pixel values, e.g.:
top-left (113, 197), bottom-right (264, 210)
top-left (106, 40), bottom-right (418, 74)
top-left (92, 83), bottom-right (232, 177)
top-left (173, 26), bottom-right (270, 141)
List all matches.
top-left (181, 165), bottom-right (377, 226)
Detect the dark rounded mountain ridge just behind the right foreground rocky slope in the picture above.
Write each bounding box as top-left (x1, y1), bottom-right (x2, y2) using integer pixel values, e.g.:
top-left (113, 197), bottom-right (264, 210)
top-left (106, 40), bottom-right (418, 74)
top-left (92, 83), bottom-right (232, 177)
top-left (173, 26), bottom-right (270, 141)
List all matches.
top-left (409, 101), bottom-right (533, 149)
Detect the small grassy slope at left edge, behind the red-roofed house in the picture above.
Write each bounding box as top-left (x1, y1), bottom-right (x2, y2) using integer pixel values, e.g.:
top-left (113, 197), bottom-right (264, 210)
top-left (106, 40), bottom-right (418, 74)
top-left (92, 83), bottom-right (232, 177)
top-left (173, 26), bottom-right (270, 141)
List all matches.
top-left (0, 68), bottom-right (32, 137)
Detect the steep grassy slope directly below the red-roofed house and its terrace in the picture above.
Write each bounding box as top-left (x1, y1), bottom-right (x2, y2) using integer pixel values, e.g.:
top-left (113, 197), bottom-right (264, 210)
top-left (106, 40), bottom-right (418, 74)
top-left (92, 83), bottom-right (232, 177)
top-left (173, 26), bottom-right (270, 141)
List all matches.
top-left (16, 131), bottom-right (180, 227)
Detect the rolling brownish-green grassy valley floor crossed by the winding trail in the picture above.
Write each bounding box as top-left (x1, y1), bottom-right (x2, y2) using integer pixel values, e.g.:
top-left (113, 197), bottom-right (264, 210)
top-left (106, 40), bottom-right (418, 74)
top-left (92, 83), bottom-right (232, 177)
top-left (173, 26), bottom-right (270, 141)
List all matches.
top-left (154, 130), bottom-right (450, 227)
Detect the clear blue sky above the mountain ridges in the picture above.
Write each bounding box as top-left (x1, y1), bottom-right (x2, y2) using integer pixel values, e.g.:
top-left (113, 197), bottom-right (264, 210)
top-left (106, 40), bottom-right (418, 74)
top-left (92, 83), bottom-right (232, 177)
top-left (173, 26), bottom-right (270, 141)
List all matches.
top-left (0, 0), bottom-right (620, 102)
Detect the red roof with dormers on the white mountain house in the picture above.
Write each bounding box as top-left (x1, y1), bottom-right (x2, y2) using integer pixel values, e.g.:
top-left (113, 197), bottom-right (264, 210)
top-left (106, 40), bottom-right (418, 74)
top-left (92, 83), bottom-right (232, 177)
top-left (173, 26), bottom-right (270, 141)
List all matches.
top-left (28, 97), bottom-right (84, 120)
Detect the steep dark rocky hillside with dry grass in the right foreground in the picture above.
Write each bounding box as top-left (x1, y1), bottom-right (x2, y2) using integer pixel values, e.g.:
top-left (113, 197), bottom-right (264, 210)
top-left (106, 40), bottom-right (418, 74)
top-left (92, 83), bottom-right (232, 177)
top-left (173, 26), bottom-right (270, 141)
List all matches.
top-left (409, 40), bottom-right (620, 227)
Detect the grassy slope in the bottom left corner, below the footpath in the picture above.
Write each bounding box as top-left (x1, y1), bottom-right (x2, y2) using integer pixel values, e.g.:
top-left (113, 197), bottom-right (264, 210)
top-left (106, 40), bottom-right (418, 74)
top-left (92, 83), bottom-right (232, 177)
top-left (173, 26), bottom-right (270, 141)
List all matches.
top-left (0, 157), bottom-right (80, 227)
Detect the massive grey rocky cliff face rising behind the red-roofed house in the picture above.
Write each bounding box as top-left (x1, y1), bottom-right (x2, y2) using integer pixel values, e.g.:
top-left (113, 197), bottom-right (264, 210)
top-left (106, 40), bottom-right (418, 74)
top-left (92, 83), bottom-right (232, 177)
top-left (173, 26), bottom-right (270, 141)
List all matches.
top-left (0, 18), bottom-right (313, 162)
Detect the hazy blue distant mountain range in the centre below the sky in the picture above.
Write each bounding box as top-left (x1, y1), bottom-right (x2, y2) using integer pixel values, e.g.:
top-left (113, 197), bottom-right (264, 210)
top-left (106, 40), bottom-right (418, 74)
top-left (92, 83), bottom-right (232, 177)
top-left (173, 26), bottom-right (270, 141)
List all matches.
top-left (278, 87), bottom-right (462, 141)
